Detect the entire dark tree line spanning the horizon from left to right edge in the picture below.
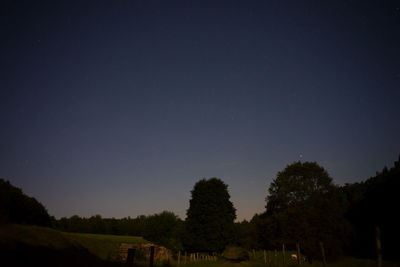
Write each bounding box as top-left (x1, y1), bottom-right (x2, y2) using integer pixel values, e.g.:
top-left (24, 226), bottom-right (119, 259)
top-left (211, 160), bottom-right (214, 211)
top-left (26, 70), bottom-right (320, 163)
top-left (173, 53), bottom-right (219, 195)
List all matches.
top-left (0, 154), bottom-right (400, 261)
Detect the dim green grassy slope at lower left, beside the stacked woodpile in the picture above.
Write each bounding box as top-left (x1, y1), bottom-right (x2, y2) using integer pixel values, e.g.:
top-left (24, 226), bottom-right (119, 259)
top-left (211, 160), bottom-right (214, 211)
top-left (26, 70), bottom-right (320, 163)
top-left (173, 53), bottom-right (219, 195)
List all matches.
top-left (0, 224), bottom-right (147, 266)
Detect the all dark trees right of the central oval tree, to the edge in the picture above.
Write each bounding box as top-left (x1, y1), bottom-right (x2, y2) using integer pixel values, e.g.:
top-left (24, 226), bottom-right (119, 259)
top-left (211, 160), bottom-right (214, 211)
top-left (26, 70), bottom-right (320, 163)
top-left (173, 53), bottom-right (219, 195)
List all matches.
top-left (238, 156), bottom-right (400, 260)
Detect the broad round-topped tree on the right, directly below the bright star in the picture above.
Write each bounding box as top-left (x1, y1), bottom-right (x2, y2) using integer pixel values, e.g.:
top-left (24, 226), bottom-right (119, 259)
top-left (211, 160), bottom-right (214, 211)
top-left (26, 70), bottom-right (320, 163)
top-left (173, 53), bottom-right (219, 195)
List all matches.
top-left (258, 162), bottom-right (350, 260)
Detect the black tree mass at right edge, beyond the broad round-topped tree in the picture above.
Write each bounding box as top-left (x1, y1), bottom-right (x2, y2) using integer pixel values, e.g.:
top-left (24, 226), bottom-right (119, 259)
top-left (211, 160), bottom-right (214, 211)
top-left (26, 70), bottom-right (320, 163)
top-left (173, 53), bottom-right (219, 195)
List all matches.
top-left (341, 156), bottom-right (400, 260)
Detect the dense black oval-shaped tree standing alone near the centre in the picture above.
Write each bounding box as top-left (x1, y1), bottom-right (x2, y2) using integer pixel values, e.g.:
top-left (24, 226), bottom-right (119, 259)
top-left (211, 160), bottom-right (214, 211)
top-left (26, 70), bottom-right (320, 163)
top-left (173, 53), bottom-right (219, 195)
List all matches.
top-left (184, 178), bottom-right (236, 252)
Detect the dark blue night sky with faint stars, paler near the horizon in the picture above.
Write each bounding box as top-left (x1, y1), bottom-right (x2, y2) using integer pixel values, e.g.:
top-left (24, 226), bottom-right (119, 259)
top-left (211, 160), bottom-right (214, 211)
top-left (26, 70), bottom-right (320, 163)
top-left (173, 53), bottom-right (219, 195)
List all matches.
top-left (0, 0), bottom-right (400, 220)
